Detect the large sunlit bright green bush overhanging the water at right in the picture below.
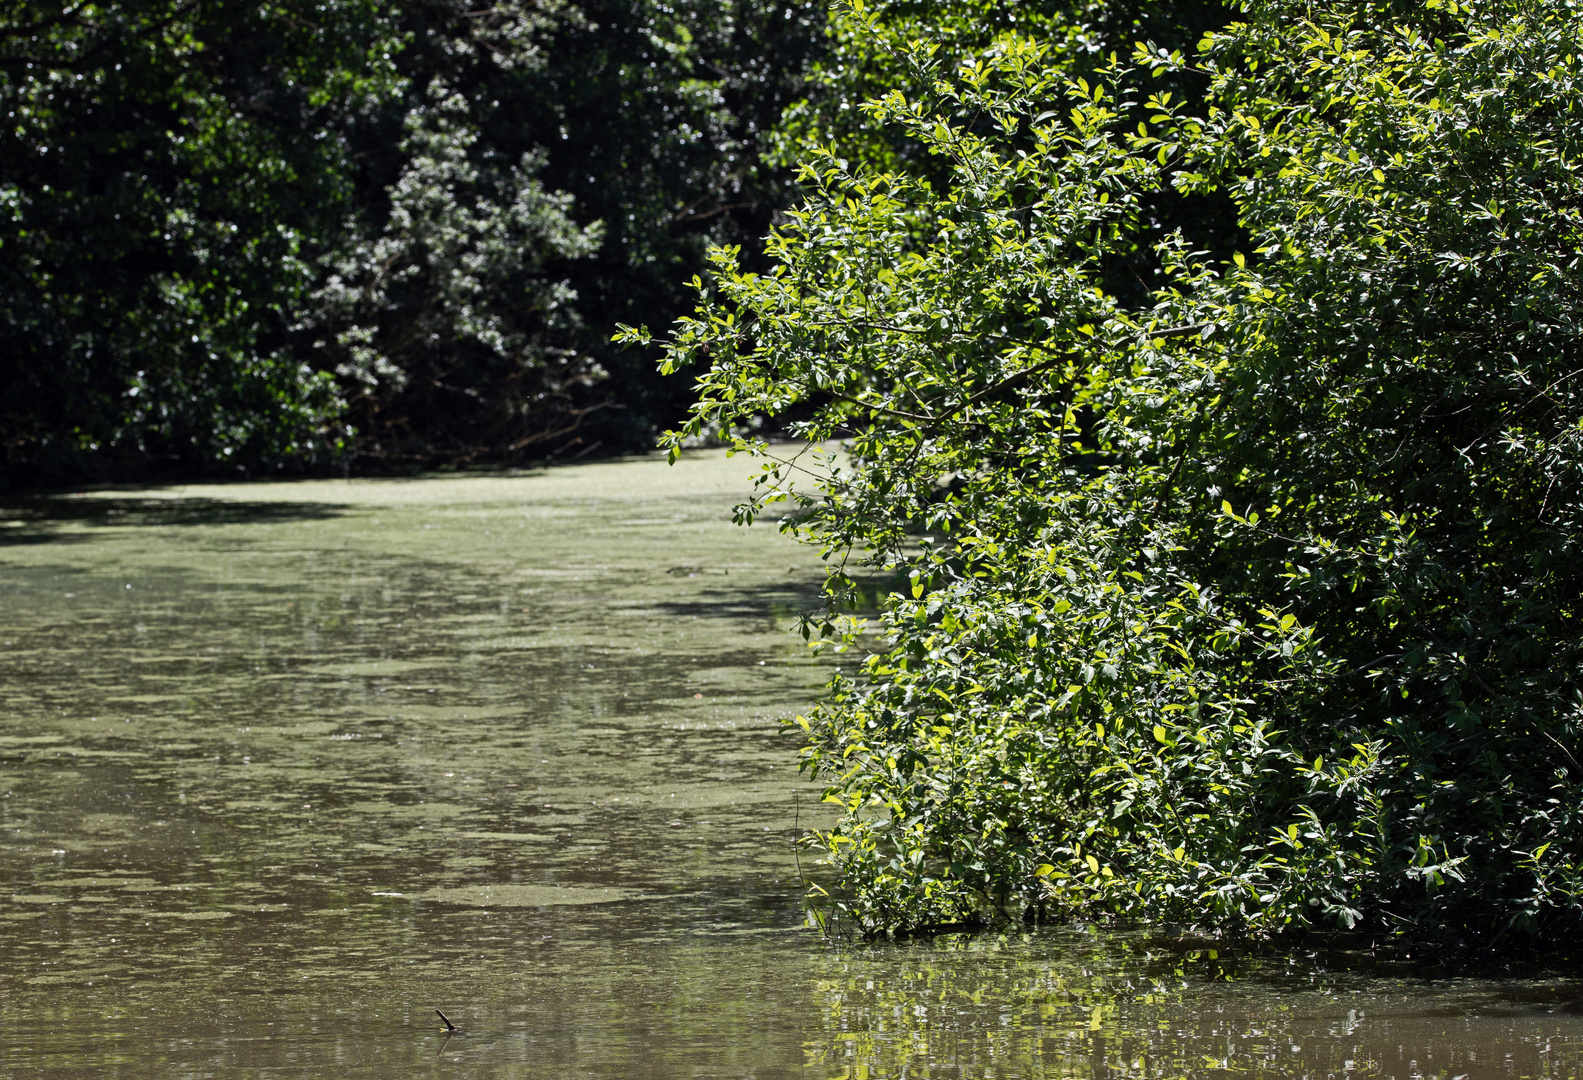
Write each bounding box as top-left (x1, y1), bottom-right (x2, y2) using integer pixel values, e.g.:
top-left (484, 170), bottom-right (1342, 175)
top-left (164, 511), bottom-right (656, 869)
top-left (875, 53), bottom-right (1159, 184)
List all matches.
top-left (633, 0), bottom-right (1583, 944)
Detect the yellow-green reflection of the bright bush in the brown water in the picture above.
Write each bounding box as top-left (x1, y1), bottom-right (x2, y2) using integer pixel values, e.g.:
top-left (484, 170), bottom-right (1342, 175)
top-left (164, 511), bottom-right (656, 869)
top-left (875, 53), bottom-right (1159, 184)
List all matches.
top-left (804, 931), bottom-right (1583, 1080)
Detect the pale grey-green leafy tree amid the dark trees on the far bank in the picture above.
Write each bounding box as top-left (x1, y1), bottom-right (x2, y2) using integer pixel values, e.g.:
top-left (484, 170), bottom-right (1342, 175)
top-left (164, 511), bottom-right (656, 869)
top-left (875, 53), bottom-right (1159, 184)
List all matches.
top-left (299, 0), bottom-right (602, 469)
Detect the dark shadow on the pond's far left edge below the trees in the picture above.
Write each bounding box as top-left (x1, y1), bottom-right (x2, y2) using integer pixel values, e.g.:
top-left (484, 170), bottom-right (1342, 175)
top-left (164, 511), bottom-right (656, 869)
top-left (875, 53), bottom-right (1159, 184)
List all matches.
top-left (0, 496), bottom-right (350, 545)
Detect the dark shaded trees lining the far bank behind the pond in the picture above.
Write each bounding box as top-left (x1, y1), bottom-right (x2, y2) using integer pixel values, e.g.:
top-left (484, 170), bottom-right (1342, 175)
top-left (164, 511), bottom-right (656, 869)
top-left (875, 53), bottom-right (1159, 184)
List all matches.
top-left (0, 0), bottom-right (822, 483)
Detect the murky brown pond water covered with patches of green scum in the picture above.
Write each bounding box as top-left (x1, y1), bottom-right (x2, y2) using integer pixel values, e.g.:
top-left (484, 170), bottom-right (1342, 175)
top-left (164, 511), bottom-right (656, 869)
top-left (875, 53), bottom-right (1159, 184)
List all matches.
top-left (0, 454), bottom-right (1583, 1080)
